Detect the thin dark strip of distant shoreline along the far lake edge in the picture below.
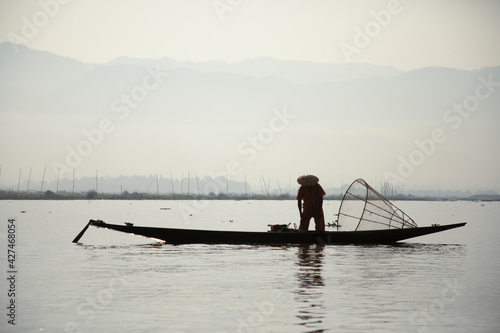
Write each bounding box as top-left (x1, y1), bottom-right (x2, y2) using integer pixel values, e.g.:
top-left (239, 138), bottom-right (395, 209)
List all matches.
top-left (0, 191), bottom-right (500, 201)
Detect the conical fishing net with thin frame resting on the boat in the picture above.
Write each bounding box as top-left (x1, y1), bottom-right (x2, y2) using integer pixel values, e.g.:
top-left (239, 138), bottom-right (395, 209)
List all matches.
top-left (338, 179), bottom-right (418, 231)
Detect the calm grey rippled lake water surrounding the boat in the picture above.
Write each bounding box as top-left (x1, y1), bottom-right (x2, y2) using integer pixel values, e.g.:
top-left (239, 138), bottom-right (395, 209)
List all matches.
top-left (0, 200), bottom-right (500, 333)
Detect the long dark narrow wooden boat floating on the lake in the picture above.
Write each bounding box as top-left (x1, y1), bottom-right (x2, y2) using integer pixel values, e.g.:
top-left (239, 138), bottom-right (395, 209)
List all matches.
top-left (73, 220), bottom-right (466, 245)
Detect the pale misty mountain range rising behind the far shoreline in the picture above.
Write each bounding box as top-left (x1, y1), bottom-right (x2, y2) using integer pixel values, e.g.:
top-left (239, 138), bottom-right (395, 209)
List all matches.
top-left (0, 43), bottom-right (500, 192)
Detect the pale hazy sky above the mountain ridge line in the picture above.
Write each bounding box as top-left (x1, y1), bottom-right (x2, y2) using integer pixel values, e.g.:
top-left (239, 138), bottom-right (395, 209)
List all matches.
top-left (0, 0), bottom-right (500, 189)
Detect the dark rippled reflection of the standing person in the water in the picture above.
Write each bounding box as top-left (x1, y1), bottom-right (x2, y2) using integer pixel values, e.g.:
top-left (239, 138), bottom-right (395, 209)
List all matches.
top-left (294, 245), bottom-right (326, 332)
